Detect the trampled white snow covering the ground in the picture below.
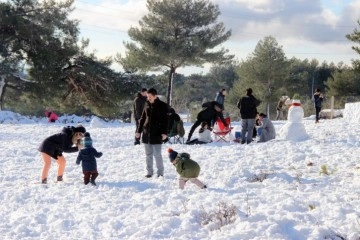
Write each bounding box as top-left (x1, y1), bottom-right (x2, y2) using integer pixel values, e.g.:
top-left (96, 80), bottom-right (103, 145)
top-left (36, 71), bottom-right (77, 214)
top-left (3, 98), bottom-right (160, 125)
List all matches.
top-left (0, 104), bottom-right (360, 240)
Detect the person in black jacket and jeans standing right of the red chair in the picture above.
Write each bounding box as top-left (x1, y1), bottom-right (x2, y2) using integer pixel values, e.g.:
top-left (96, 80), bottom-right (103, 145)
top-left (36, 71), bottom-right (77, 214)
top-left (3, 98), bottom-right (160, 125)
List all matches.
top-left (237, 88), bottom-right (260, 144)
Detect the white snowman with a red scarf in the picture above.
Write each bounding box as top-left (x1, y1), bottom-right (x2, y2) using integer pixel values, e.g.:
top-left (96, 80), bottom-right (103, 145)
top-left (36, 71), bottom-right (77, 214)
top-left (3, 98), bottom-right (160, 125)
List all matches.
top-left (279, 99), bottom-right (309, 141)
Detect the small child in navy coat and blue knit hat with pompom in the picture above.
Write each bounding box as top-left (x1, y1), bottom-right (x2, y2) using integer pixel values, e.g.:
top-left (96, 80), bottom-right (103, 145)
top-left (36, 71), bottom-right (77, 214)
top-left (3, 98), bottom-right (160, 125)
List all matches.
top-left (76, 132), bottom-right (102, 186)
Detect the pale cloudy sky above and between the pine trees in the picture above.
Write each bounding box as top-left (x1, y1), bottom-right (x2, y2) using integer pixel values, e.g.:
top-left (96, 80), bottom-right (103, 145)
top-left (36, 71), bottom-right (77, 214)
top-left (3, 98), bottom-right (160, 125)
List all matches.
top-left (72, 0), bottom-right (360, 75)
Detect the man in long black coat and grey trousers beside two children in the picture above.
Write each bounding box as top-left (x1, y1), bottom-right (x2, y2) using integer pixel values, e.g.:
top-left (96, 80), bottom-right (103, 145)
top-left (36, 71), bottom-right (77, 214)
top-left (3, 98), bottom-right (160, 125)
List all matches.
top-left (135, 88), bottom-right (168, 178)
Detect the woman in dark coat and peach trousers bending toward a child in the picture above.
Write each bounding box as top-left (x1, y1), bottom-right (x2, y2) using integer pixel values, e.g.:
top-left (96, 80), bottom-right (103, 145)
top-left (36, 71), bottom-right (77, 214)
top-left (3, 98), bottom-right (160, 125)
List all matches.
top-left (38, 125), bottom-right (86, 184)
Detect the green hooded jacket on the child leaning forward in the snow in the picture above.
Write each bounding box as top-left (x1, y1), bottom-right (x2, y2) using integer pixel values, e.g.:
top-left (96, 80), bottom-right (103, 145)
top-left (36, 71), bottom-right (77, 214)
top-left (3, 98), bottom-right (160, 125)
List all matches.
top-left (174, 153), bottom-right (200, 178)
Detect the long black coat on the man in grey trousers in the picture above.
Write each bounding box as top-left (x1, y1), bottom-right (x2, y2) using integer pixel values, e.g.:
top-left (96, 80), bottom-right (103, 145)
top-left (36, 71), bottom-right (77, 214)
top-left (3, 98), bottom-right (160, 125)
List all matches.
top-left (136, 98), bottom-right (168, 144)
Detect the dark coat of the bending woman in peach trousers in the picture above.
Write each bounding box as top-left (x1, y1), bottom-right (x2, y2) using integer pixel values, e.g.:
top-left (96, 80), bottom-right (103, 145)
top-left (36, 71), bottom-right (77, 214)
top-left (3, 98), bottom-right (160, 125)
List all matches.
top-left (38, 127), bottom-right (78, 159)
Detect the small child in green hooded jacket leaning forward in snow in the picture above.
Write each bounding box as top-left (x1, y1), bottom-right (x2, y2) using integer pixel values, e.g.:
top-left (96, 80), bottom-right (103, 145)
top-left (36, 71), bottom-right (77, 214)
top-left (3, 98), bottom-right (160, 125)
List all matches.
top-left (168, 148), bottom-right (206, 189)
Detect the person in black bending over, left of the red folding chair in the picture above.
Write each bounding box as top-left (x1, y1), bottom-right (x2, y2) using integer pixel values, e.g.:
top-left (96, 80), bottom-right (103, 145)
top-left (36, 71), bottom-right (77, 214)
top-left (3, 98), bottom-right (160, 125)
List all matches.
top-left (187, 101), bottom-right (228, 142)
